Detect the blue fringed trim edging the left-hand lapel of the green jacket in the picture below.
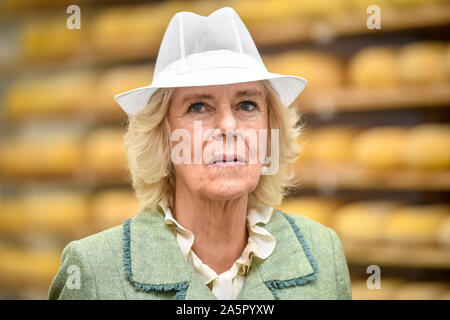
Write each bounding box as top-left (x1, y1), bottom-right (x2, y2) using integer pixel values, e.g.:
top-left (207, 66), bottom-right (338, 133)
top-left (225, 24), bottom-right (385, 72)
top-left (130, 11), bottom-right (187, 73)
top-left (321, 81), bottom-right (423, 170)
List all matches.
top-left (123, 219), bottom-right (189, 300)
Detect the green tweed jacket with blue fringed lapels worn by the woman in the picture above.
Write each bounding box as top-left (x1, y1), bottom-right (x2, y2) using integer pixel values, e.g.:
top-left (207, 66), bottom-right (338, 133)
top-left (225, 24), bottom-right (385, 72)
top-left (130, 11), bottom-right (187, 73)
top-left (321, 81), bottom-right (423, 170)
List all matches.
top-left (48, 208), bottom-right (352, 300)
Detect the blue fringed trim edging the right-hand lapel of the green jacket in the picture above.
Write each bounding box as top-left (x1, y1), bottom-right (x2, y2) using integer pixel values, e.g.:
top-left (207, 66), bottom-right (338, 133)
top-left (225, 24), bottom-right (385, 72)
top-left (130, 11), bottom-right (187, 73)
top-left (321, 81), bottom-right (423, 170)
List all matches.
top-left (265, 211), bottom-right (319, 300)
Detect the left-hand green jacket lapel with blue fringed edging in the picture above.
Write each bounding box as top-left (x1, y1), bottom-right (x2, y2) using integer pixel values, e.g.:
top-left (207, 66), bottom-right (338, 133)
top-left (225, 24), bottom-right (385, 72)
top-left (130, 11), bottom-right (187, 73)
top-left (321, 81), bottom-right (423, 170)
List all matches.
top-left (123, 208), bottom-right (215, 300)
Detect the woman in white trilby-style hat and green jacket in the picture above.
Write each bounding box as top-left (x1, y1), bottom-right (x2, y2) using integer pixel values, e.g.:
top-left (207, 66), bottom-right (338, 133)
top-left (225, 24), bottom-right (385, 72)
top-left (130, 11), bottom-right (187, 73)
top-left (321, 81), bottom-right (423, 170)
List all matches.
top-left (49, 7), bottom-right (351, 299)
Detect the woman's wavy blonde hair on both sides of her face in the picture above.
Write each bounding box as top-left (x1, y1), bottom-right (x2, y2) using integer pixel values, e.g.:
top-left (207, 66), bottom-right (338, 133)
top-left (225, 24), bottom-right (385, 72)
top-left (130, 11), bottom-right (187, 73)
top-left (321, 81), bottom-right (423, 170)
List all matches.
top-left (124, 80), bottom-right (303, 209)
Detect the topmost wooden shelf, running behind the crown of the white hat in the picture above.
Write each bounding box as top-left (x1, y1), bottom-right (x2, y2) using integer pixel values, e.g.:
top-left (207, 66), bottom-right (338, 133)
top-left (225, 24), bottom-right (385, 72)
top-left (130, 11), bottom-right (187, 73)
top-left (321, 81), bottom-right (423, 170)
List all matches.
top-left (0, 3), bottom-right (450, 76)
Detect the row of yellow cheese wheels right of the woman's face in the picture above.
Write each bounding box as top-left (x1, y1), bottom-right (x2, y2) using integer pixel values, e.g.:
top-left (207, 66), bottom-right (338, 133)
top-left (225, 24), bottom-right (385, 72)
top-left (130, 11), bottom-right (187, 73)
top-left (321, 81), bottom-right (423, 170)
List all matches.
top-left (297, 123), bottom-right (450, 170)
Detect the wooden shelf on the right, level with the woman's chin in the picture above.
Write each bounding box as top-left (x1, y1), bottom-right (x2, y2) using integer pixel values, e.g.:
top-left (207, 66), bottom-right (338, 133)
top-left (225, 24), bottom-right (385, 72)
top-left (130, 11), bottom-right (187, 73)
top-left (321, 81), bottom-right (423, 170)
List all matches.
top-left (295, 164), bottom-right (450, 191)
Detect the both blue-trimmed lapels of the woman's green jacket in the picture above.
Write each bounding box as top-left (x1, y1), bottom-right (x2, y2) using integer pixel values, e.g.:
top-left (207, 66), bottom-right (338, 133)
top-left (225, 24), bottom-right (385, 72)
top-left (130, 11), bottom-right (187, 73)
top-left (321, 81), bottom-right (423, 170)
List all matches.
top-left (123, 207), bottom-right (318, 300)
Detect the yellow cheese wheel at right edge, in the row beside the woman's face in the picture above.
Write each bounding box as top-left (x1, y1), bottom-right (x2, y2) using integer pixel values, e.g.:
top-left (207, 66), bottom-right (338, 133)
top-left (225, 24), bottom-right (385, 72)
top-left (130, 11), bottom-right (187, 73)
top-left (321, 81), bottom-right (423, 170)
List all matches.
top-left (402, 123), bottom-right (450, 169)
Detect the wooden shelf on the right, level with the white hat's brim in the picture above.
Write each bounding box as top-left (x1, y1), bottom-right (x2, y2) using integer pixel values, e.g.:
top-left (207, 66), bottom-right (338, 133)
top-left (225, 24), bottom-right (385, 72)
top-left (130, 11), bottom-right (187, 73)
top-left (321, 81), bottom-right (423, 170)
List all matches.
top-left (298, 83), bottom-right (450, 113)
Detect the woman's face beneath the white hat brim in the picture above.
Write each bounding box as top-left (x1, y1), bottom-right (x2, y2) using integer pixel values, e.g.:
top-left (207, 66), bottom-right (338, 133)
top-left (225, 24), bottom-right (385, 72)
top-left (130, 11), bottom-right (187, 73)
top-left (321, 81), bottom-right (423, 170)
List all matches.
top-left (168, 81), bottom-right (268, 200)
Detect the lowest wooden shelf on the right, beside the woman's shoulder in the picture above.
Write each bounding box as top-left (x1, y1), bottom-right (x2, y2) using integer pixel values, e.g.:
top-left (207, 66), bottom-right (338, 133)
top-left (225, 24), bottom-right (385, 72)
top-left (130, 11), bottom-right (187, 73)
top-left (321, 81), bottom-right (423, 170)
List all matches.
top-left (342, 241), bottom-right (450, 269)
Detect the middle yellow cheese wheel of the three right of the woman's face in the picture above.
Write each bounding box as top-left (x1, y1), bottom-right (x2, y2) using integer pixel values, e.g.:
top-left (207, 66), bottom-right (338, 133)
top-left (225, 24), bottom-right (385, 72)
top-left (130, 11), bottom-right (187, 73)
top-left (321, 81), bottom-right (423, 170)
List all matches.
top-left (352, 126), bottom-right (407, 169)
